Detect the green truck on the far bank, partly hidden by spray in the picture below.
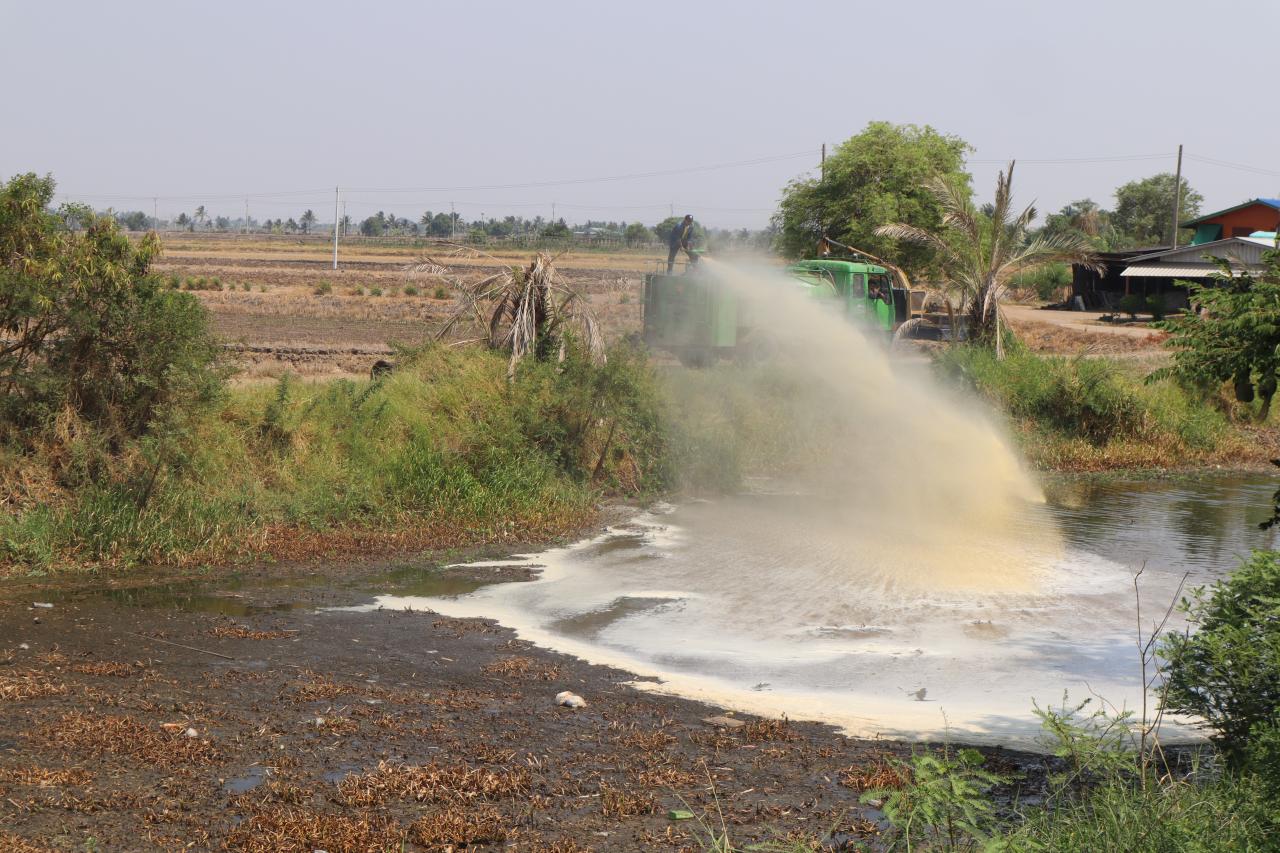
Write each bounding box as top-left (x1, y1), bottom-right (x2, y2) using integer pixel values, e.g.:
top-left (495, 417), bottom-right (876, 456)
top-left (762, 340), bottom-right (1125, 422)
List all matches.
top-left (644, 249), bottom-right (942, 366)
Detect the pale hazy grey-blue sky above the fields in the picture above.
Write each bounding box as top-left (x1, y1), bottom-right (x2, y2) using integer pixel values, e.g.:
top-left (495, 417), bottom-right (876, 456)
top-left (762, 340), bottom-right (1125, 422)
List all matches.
top-left (0, 0), bottom-right (1280, 228)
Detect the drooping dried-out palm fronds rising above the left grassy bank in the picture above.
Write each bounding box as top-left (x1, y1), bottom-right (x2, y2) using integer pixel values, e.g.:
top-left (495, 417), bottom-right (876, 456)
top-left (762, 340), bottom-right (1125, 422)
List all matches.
top-left (408, 252), bottom-right (604, 379)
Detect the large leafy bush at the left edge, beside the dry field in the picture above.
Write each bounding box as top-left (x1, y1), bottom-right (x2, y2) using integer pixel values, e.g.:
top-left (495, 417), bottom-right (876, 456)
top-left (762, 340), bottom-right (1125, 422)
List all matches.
top-left (0, 174), bottom-right (220, 447)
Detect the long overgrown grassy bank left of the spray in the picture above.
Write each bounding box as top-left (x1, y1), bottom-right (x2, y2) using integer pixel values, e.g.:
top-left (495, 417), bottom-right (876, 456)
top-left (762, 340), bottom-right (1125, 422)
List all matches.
top-left (0, 347), bottom-right (662, 574)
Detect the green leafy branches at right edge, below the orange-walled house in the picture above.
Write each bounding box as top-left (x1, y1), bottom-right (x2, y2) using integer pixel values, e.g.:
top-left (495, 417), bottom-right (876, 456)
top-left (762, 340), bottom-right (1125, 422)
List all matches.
top-left (1153, 245), bottom-right (1280, 420)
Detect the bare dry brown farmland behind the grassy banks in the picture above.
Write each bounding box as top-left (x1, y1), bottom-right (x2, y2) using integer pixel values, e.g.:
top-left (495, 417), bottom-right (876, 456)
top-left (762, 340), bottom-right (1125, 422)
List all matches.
top-left (156, 234), bottom-right (1162, 382)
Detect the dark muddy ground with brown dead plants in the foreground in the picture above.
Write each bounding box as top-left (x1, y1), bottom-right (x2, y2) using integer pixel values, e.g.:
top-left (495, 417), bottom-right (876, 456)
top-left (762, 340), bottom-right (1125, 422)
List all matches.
top-left (0, 540), bottom-right (1037, 853)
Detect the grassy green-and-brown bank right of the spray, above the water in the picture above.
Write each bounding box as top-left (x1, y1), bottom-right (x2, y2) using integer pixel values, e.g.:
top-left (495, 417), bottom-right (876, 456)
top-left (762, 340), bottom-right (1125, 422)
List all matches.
top-left (934, 347), bottom-right (1276, 471)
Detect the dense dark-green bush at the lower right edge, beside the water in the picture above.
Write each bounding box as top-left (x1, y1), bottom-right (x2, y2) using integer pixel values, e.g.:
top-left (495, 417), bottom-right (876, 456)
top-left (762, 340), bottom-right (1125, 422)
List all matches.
top-left (1161, 551), bottom-right (1280, 768)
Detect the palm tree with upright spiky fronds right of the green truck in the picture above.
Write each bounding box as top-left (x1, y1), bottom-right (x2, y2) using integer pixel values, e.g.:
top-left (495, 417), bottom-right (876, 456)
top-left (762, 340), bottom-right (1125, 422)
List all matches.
top-left (876, 163), bottom-right (1098, 355)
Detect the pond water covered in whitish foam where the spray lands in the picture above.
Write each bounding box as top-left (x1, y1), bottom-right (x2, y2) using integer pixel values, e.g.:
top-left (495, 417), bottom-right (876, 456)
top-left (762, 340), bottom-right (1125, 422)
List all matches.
top-left (358, 475), bottom-right (1275, 743)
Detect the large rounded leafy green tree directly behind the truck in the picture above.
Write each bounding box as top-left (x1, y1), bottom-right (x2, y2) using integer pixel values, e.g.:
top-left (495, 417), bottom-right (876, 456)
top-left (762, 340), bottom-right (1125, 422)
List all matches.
top-left (774, 122), bottom-right (970, 274)
